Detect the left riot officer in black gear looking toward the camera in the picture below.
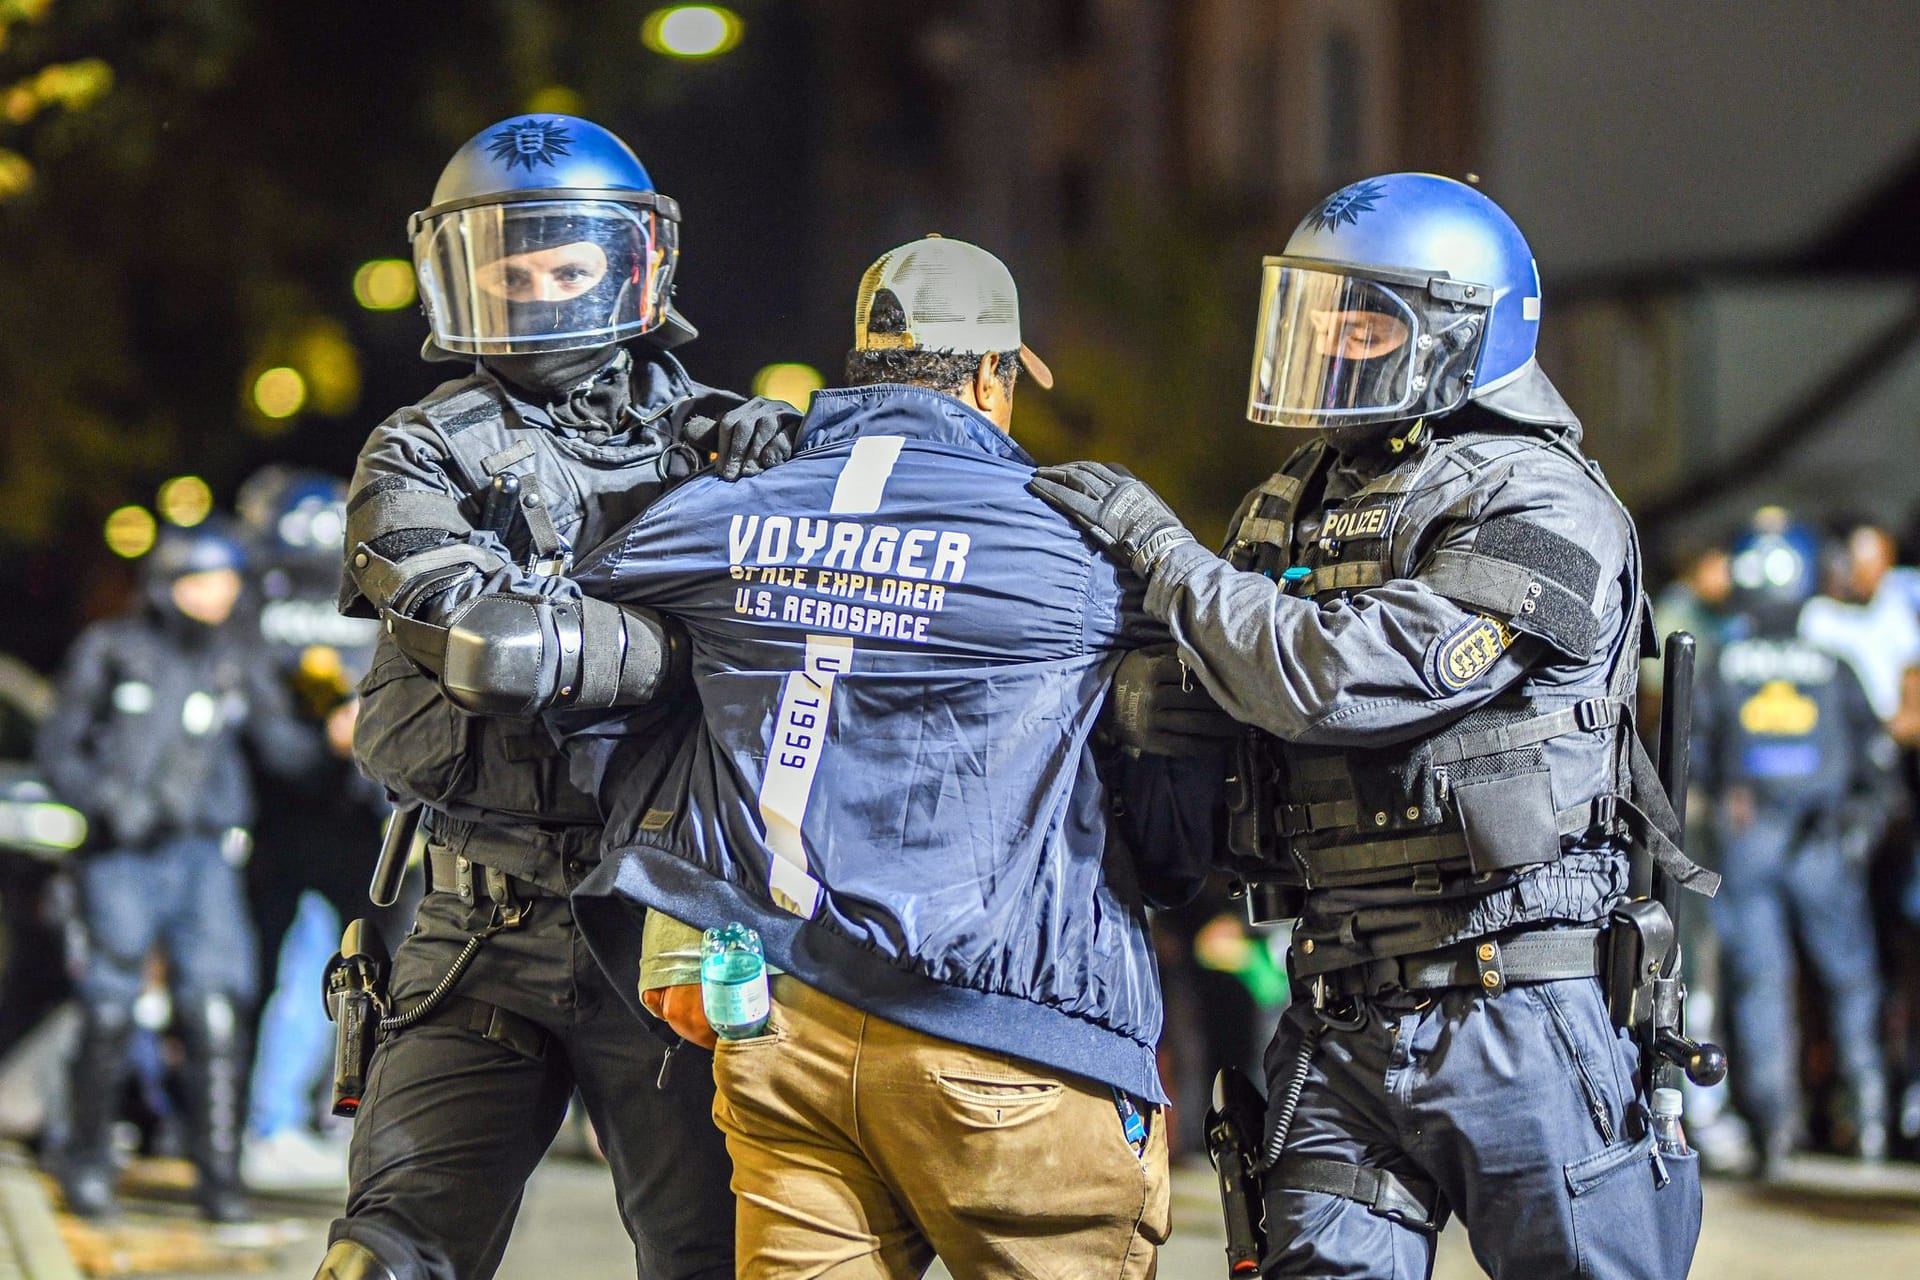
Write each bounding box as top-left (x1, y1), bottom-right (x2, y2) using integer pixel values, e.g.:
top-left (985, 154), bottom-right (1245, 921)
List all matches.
top-left (321, 115), bottom-right (797, 1280)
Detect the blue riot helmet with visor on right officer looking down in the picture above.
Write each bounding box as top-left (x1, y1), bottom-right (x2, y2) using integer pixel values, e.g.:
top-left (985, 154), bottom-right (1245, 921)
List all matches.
top-left (1246, 173), bottom-right (1572, 428)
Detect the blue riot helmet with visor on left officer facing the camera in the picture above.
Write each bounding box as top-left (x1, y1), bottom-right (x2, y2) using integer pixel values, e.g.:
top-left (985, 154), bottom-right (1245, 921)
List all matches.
top-left (407, 115), bottom-right (693, 355)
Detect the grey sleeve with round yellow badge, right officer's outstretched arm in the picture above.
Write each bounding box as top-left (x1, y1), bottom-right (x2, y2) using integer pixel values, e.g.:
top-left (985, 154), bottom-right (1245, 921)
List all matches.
top-left (1146, 452), bottom-right (1626, 747)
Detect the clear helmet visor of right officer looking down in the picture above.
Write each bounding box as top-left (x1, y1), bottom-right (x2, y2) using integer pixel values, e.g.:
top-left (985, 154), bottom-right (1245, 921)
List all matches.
top-left (1246, 259), bottom-right (1486, 428)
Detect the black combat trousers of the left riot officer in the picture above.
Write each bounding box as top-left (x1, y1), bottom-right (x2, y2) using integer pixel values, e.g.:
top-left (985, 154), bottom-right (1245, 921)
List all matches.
top-left (330, 892), bottom-right (733, 1280)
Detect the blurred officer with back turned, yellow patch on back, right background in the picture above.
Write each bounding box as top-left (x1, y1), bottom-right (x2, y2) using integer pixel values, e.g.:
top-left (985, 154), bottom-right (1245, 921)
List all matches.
top-left (1693, 509), bottom-right (1899, 1176)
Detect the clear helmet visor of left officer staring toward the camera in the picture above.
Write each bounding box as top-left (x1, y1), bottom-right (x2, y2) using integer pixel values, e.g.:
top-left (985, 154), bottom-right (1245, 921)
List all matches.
top-left (413, 200), bottom-right (680, 355)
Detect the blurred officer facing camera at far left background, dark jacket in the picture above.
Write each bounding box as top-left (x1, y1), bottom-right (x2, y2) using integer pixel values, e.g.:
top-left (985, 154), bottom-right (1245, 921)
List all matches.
top-left (36, 518), bottom-right (315, 1222)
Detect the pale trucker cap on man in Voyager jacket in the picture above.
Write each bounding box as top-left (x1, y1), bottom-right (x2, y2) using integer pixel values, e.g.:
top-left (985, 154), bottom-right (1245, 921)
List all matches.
top-left (852, 236), bottom-right (1054, 388)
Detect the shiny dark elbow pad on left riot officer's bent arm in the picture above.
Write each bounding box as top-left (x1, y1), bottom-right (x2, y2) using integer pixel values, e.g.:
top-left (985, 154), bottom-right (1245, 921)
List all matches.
top-left (440, 595), bottom-right (689, 718)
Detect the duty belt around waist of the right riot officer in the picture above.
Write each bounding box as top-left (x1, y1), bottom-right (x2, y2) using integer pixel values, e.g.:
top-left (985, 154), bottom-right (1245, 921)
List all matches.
top-left (1288, 929), bottom-right (1607, 1007)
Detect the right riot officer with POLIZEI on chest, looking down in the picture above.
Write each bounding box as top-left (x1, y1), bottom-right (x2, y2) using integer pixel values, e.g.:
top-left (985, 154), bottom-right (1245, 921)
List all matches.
top-left (1035, 173), bottom-right (1699, 1280)
